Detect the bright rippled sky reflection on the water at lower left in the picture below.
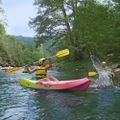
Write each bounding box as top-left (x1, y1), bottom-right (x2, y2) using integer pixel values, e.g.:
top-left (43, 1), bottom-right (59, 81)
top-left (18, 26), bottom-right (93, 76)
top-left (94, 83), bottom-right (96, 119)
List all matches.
top-left (0, 71), bottom-right (26, 120)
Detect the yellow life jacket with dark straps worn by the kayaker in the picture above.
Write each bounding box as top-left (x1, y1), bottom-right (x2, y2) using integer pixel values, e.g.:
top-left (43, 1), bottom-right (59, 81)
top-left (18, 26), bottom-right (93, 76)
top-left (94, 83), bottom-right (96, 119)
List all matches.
top-left (36, 66), bottom-right (47, 79)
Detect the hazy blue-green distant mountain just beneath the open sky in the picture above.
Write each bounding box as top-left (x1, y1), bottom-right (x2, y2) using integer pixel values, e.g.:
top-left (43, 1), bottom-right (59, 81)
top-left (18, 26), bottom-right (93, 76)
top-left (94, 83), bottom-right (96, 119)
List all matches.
top-left (15, 36), bottom-right (35, 47)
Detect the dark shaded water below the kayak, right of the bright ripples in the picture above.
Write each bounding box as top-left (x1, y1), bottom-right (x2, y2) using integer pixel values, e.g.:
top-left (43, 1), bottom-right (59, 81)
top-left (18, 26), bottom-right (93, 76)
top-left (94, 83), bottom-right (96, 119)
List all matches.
top-left (23, 88), bottom-right (120, 120)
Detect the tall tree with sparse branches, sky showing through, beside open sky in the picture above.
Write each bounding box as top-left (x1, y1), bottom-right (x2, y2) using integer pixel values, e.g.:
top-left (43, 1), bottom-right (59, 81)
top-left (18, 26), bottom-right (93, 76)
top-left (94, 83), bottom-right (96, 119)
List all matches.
top-left (30, 0), bottom-right (86, 60)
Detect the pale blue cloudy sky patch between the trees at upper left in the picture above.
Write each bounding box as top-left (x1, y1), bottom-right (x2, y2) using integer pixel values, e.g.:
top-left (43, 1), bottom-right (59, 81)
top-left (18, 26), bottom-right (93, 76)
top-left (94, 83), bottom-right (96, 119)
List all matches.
top-left (2, 0), bottom-right (36, 36)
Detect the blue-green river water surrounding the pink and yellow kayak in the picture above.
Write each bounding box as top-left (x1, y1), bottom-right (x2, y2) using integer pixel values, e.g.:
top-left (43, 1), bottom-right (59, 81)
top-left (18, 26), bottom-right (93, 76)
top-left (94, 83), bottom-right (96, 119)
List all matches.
top-left (0, 71), bottom-right (120, 120)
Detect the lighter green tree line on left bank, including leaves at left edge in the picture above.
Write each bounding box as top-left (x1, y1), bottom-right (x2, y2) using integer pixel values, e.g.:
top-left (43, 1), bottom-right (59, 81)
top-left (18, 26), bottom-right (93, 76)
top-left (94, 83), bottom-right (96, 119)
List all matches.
top-left (0, 0), bottom-right (49, 66)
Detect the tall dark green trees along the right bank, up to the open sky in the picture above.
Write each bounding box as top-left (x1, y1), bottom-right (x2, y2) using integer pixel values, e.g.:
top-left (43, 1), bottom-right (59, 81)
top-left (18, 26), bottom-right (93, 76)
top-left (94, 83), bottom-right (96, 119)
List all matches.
top-left (29, 0), bottom-right (120, 62)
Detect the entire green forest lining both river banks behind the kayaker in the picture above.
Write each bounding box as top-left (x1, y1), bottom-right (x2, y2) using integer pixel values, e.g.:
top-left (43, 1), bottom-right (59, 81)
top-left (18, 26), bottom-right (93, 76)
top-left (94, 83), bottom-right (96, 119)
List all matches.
top-left (0, 0), bottom-right (120, 66)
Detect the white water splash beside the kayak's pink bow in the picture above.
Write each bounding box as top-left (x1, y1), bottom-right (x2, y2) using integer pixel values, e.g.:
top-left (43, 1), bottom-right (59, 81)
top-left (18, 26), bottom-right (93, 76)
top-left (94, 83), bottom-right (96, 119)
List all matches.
top-left (91, 55), bottom-right (113, 88)
